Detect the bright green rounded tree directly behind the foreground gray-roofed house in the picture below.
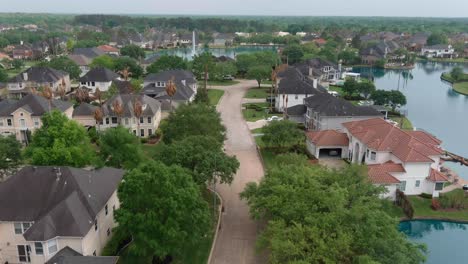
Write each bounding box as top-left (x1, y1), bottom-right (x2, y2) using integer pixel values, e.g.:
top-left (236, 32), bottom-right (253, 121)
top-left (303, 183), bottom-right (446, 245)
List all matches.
top-left (26, 110), bottom-right (96, 167)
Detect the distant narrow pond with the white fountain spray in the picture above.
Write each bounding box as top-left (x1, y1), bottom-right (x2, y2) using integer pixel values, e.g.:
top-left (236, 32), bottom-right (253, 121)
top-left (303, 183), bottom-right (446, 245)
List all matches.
top-left (147, 45), bottom-right (278, 60)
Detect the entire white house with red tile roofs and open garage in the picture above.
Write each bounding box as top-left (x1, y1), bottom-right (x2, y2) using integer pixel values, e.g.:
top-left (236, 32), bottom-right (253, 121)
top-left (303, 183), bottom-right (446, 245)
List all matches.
top-left (307, 118), bottom-right (448, 199)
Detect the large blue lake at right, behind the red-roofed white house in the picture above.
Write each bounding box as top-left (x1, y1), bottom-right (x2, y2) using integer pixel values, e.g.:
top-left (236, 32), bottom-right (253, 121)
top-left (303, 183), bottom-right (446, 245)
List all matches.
top-left (353, 62), bottom-right (468, 179)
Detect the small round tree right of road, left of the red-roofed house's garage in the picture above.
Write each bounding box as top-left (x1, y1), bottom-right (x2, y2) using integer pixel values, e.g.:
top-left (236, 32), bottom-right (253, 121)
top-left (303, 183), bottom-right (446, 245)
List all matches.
top-left (262, 120), bottom-right (305, 151)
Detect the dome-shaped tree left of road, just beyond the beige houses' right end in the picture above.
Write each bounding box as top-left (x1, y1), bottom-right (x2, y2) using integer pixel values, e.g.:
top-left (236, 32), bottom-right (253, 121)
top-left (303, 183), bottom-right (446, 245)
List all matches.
top-left (161, 104), bottom-right (226, 143)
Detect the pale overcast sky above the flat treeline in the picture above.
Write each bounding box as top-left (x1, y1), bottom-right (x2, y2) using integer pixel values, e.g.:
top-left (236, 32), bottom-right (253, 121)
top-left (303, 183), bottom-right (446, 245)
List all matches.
top-left (0, 0), bottom-right (468, 17)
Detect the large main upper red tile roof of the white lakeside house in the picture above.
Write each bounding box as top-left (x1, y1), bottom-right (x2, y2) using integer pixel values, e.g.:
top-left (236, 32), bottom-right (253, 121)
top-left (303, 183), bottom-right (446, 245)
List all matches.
top-left (343, 118), bottom-right (443, 162)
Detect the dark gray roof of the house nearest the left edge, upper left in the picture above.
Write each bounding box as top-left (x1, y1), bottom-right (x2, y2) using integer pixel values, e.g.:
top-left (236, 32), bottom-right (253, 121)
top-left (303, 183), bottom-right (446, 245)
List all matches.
top-left (9, 67), bottom-right (68, 83)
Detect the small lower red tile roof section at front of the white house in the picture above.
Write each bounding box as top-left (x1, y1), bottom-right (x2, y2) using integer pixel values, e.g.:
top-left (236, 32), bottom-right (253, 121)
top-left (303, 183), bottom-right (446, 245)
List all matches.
top-left (367, 161), bottom-right (406, 184)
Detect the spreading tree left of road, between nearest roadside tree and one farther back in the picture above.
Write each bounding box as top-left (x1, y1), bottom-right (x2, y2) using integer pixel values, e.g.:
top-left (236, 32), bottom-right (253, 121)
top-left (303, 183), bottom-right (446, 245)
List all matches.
top-left (155, 136), bottom-right (239, 185)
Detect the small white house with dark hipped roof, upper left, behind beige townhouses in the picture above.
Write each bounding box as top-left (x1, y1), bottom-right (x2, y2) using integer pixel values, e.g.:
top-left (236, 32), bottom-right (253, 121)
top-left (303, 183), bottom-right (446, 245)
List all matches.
top-left (79, 67), bottom-right (120, 93)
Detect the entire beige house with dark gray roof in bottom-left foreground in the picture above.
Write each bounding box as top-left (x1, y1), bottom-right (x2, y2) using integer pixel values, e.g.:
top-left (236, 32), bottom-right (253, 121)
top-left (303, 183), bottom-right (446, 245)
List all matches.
top-left (0, 166), bottom-right (124, 264)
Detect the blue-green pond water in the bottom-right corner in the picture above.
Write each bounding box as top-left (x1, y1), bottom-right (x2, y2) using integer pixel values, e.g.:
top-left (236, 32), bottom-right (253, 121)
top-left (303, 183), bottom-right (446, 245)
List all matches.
top-left (399, 220), bottom-right (468, 264)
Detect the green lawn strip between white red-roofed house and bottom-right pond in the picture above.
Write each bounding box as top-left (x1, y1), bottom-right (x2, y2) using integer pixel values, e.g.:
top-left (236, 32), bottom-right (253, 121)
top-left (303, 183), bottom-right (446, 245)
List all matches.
top-left (408, 196), bottom-right (468, 221)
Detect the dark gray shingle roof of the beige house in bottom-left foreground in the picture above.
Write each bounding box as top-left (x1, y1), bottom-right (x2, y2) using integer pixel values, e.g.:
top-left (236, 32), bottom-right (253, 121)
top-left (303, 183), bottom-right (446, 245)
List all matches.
top-left (0, 166), bottom-right (124, 241)
